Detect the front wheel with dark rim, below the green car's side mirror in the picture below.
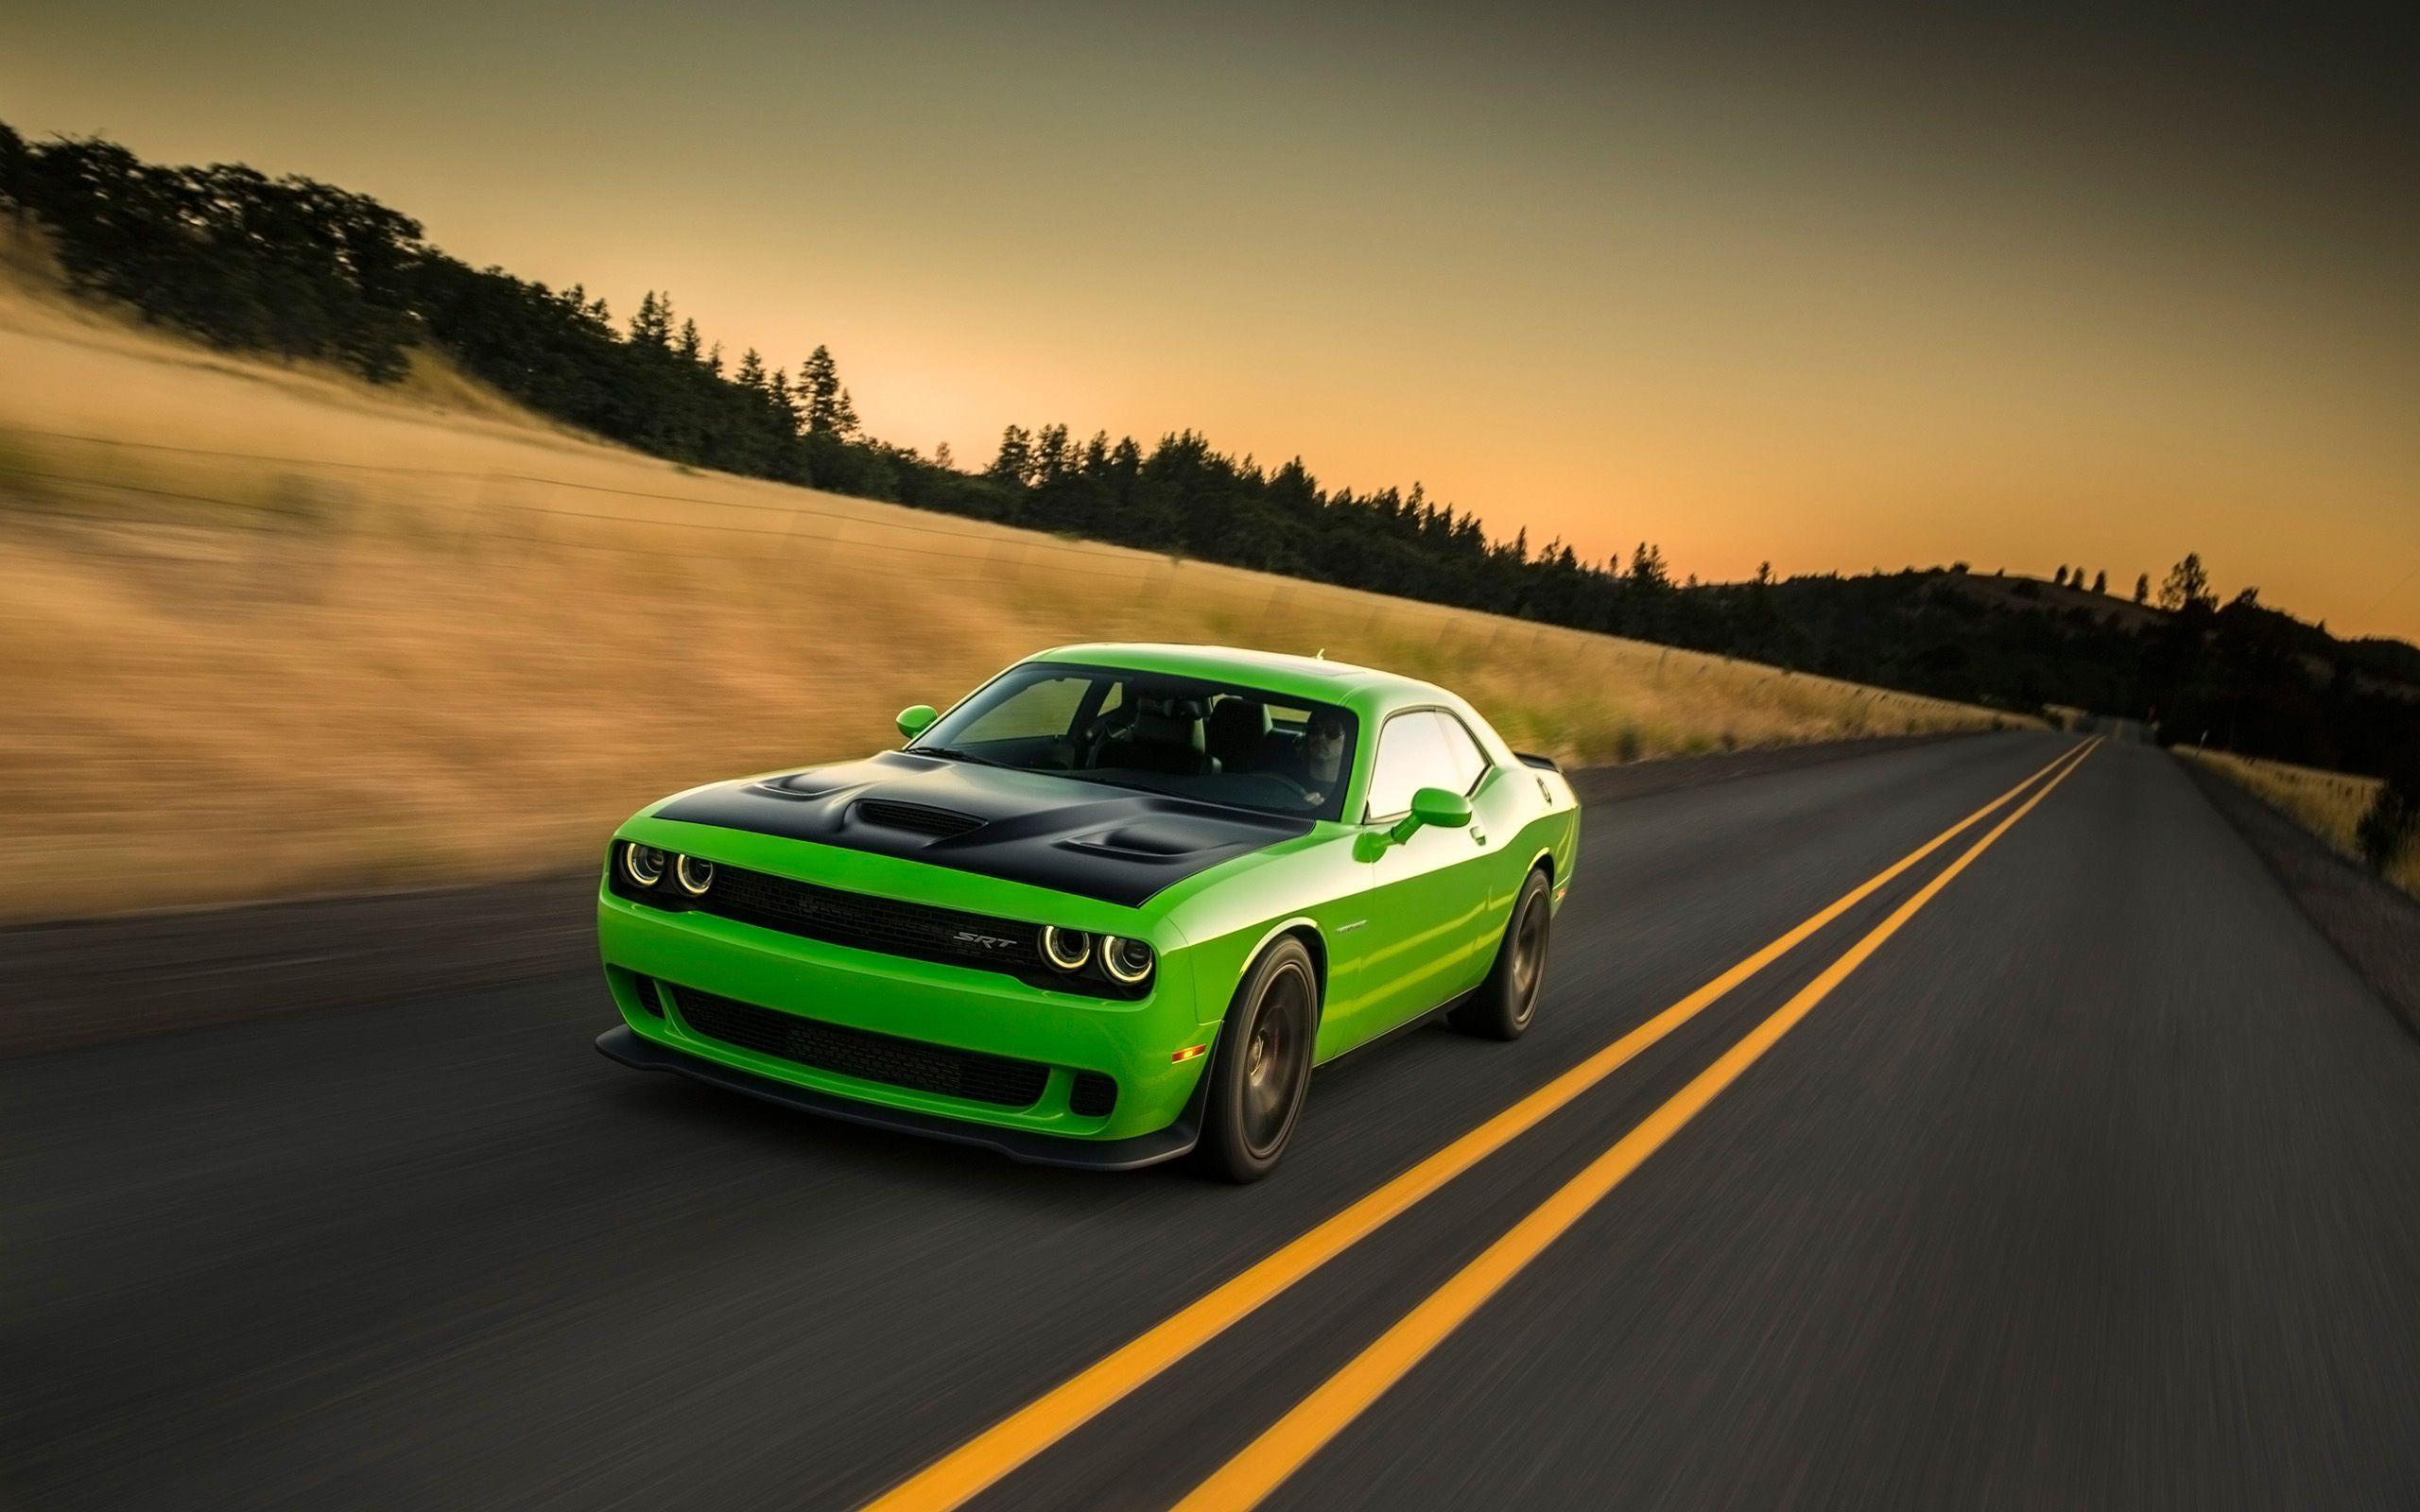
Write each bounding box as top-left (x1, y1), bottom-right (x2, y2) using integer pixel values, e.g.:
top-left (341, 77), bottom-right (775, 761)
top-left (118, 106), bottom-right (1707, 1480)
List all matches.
top-left (1193, 936), bottom-right (1319, 1183)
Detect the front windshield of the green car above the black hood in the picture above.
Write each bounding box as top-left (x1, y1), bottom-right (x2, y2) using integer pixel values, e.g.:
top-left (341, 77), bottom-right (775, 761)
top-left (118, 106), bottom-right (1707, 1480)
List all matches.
top-left (908, 661), bottom-right (1357, 820)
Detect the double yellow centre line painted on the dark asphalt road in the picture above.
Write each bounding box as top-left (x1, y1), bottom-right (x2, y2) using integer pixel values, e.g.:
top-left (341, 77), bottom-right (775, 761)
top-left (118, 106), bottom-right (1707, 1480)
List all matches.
top-left (872, 740), bottom-right (2099, 1512)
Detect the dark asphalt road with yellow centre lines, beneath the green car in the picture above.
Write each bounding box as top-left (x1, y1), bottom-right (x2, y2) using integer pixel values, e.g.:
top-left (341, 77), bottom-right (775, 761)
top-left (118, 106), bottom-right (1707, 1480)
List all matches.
top-left (0, 733), bottom-right (2420, 1509)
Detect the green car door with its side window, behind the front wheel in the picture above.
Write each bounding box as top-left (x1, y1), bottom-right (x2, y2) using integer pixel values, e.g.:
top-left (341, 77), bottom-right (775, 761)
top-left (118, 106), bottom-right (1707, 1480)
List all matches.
top-left (1322, 709), bottom-right (1494, 1050)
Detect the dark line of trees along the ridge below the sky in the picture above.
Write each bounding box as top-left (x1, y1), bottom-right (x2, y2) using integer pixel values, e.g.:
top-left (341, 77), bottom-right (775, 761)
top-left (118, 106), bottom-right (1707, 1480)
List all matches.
top-left (0, 124), bottom-right (2420, 856)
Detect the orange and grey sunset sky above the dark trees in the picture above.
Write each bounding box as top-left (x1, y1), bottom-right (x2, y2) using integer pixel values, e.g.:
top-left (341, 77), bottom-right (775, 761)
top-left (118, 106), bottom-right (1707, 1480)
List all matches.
top-left (0, 0), bottom-right (2420, 639)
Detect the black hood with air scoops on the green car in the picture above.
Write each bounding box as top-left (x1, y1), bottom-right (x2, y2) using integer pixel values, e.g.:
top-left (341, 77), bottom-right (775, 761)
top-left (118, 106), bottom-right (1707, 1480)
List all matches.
top-left (656, 750), bottom-right (1312, 907)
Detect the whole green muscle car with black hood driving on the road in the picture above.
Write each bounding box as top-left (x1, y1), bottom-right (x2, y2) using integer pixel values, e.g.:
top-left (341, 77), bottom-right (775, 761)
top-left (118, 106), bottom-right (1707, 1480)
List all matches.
top-left (597, 646), bottom-right (1581, 1180)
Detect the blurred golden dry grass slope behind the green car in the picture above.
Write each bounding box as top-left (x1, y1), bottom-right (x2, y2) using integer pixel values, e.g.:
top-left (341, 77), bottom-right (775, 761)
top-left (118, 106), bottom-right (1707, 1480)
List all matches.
top-left (0, 266), bottom-right (2021, 919)
